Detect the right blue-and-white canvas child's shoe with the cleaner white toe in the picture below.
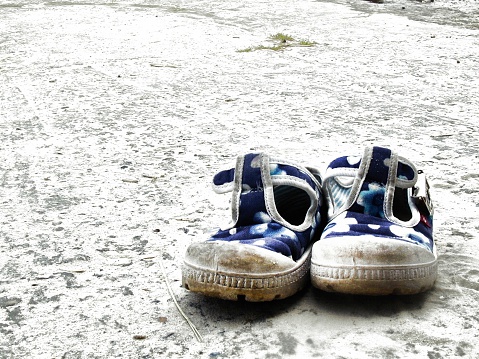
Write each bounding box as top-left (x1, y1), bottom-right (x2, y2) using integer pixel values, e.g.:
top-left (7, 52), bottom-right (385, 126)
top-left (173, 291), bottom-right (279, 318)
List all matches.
top-left (311, 147), bottom-right (437, 295)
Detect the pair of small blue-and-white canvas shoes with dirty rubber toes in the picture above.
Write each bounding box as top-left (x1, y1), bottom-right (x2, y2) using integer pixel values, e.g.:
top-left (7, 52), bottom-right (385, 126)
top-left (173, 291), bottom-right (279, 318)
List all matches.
top-left (182, 147), bottom-right (437, 301)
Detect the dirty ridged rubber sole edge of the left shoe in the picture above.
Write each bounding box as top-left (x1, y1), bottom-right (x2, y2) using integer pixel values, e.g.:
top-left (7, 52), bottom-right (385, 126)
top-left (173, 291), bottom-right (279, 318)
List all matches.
top-left (182, 251), bottom-right (311, 302)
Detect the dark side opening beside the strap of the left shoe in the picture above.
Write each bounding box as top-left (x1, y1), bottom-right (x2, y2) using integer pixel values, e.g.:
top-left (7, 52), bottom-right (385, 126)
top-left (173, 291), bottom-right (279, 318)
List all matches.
top-left (273, 186), bottom-right (311, 226)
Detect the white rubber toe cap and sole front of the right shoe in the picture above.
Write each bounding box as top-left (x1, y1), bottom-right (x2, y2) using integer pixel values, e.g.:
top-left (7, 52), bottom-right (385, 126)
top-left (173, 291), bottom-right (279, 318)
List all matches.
top-left (311, 237), bottom-right (437, 295)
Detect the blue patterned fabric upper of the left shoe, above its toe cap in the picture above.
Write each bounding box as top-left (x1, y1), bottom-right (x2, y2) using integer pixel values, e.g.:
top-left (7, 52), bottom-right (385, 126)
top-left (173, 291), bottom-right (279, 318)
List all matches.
top-left (209, 154), bottom-right (322, 260)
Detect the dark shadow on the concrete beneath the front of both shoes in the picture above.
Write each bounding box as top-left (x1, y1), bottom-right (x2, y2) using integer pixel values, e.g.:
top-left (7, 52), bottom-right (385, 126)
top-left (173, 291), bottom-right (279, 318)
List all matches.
top-left (182, 286), bottom-right (431, 330)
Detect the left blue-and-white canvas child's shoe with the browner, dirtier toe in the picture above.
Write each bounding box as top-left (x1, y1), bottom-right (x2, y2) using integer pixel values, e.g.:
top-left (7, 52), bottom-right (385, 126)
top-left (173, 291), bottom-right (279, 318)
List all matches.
top-left (182, 154), bottom-right (322, 302)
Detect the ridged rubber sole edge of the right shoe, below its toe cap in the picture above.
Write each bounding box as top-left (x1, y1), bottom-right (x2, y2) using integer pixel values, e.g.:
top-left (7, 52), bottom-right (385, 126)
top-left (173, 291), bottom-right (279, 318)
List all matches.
top-left (311, 260), bottom-right (437, 295)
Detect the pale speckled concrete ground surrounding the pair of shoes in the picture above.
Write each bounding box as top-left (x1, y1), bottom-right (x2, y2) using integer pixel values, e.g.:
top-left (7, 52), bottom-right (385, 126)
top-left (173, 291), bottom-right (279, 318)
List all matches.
top-left (0, 0), bottom-right (479, 359)
